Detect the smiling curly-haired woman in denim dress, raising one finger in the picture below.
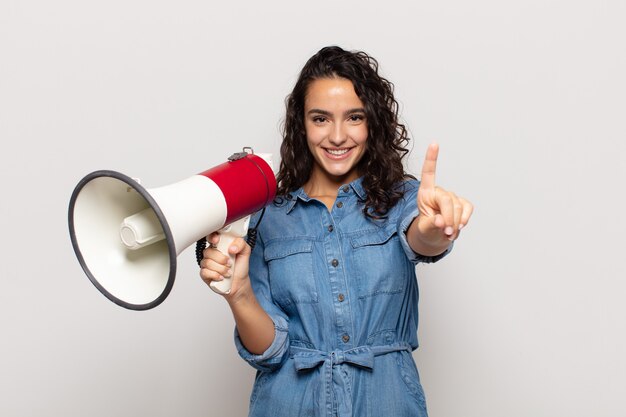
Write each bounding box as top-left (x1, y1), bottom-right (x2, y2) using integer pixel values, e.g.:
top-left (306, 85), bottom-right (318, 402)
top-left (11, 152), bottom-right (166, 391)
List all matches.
top-left (200, 47), bottom-right (472, 417)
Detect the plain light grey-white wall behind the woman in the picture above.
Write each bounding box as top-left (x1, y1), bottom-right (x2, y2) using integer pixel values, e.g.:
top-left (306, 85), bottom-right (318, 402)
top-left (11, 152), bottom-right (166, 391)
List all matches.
top-left (0, 0), bottom-right (626, 417)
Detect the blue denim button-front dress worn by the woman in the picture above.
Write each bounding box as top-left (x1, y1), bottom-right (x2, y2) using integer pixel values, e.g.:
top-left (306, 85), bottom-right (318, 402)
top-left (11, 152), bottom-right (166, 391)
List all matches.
top-left (235, 179), bottom-right (450, 417)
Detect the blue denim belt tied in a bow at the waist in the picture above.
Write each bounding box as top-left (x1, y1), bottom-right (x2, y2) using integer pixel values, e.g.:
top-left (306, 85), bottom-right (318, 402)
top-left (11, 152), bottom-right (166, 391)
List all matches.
top-left (290, 343), bottom-right (412, 417)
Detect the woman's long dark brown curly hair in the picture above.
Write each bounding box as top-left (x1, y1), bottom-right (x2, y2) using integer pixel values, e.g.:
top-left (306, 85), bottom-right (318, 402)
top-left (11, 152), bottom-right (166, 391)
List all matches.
top-left (277, 46), bottom-right (413, 218)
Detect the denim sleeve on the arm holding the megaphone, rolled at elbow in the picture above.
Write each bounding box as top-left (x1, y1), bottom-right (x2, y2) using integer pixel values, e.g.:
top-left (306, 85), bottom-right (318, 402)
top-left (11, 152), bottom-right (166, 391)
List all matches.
top-left (235, 226), bottom-right (289, 372)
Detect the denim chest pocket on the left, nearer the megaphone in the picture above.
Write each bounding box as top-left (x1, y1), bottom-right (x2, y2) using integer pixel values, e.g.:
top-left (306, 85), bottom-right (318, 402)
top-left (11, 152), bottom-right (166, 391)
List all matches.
top-left (264, 239), bottom-right (318, 307)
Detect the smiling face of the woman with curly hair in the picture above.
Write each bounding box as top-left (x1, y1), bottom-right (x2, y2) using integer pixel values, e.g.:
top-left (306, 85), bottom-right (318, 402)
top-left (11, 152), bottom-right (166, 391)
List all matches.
top-left (304, 78), bottom-right (367, 183)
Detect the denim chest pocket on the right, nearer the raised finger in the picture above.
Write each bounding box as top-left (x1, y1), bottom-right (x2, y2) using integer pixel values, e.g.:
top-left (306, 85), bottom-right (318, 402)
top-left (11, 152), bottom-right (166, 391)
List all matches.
top-left (350, 227), bottom-right (408, 298)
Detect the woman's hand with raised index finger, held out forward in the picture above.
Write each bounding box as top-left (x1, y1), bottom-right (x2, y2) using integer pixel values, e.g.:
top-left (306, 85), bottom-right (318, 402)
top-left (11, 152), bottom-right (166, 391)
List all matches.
top-left (411, 143), bottom-right (474, 255)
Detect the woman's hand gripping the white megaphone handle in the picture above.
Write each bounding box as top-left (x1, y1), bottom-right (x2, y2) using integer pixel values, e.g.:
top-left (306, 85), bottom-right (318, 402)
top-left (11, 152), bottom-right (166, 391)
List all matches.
top-left (200, 232), bottom-right (251, 303)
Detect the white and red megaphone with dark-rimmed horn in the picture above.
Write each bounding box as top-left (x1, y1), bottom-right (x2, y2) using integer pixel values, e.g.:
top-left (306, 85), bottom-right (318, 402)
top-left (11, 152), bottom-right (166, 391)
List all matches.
top-left (68, 148), bottom-right (276, 310)
